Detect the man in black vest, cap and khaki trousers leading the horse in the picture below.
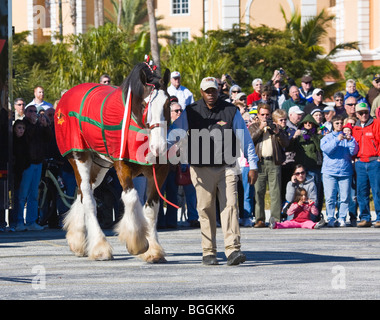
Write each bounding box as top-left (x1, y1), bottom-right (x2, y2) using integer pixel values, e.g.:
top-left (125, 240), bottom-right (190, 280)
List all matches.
top-left (168, 77), bottom-right (258, 266)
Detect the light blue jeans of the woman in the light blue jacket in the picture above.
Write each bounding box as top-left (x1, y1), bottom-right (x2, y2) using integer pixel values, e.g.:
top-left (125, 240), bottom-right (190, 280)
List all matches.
top-left (322, 173), bottom-right (351, 221)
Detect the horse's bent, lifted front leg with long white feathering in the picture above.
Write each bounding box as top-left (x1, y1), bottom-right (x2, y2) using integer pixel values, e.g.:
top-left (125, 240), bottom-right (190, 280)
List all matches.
top-left (114, 161), bottom-right (149, 255)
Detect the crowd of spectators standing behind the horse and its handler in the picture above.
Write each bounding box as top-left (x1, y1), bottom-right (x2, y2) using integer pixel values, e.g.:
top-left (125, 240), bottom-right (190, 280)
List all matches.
top-left (0, 69), bottom-right (380, 231)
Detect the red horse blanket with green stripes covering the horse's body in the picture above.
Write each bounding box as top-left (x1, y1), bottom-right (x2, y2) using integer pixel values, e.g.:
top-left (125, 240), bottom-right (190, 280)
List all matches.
top-left (55, 83), bottom-right (149, 165)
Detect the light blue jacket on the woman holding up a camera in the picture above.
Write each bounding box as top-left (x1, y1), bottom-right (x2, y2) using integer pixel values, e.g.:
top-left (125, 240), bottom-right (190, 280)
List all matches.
top-left (321, 131), bottom-right (359, 177)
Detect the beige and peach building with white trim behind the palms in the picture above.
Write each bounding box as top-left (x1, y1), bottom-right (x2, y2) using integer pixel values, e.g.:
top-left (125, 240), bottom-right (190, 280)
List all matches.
top-left (12, 0), bottom-right (380, 69)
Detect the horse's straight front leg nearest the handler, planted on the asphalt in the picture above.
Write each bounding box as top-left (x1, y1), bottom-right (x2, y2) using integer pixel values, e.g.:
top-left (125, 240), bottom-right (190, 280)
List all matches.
top-left (140, 166), bottom-right (169, 263)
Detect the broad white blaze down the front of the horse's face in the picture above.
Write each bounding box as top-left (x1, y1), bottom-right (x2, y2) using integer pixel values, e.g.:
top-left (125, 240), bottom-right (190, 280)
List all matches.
top-left (147, 90), bottom-right (167, 157)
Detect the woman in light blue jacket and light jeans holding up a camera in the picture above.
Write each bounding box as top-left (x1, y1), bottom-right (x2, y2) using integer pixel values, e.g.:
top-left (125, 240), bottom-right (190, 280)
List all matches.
top-left (321, 116), bottom-right (358, 227)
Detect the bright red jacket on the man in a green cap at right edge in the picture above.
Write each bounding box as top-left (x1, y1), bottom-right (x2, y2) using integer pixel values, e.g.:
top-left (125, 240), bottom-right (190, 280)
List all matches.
top-left (352, 118), bottom-right (380, 162)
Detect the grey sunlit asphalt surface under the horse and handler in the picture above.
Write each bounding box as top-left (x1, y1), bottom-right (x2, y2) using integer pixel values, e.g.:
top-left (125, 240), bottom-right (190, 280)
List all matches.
top-left (0, 211), bottom-right (380, 302)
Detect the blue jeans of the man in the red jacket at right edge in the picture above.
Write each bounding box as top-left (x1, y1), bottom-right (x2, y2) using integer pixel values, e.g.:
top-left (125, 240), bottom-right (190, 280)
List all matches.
top-left (355, 160), bottom-right (380, 221)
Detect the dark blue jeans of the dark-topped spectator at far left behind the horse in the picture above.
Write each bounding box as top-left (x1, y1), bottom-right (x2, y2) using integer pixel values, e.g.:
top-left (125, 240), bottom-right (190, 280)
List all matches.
top-left (17, 163), bottom-right (42, 225)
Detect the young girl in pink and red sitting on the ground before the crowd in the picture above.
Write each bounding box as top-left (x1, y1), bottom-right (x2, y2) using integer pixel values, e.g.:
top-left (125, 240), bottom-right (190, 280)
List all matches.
top-left (269, 188), bottom-right (325, 229)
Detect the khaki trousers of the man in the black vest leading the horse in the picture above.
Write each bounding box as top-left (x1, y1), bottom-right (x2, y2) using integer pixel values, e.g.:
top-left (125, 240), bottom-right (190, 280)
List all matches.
top-left (190, 166), bottom-right (240, 257)
